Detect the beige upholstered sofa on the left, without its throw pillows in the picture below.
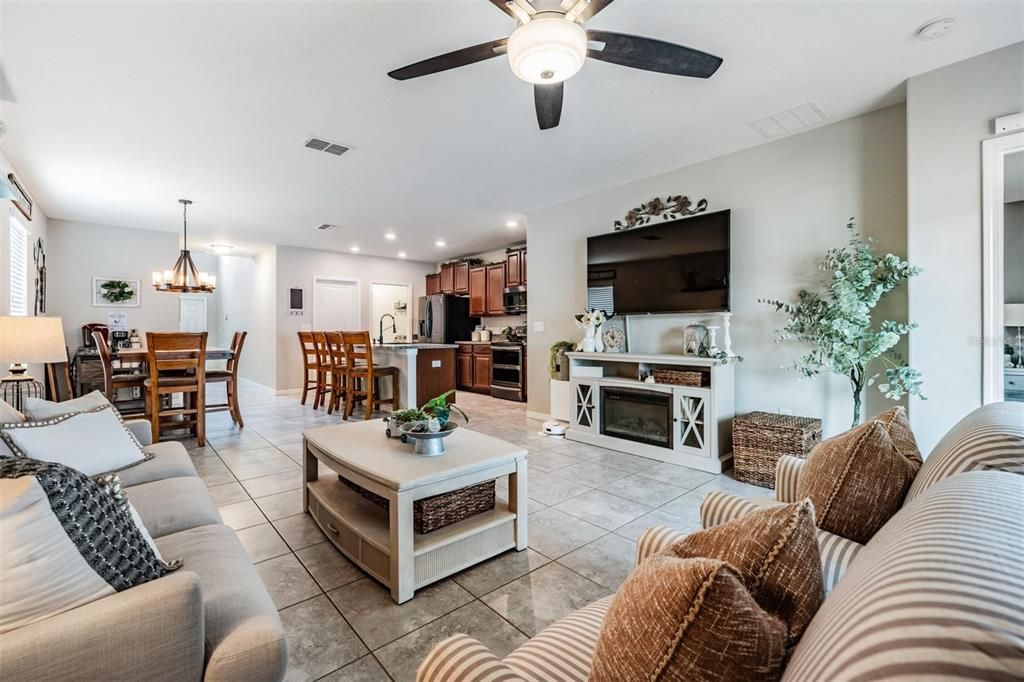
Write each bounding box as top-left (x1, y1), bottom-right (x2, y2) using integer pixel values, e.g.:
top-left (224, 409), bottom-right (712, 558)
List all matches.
top-left (0, 420), bottom-right (288, 682)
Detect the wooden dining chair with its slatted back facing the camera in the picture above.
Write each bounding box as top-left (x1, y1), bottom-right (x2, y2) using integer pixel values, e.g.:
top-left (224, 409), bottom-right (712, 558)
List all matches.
top-left (144, 332), bottom-right (207, 447)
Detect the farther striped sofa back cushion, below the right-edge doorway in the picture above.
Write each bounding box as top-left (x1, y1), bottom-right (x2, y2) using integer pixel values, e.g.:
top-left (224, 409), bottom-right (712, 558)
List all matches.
top-left (904, 402), bottom-right (1024, 504)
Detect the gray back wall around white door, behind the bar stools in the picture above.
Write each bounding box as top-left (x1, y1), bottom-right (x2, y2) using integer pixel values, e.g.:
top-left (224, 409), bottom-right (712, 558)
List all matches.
top-left (268, 247), bottom-right (436, 390)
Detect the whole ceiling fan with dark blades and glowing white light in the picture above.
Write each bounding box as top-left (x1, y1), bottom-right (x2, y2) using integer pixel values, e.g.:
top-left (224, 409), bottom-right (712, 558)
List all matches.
top-left (388, 0), bottom-right (722, 130)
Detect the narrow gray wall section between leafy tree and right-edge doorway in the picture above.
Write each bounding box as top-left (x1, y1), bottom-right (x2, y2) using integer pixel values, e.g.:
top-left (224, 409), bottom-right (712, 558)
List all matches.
top-left (906, 43), bottom-right (1024, 452)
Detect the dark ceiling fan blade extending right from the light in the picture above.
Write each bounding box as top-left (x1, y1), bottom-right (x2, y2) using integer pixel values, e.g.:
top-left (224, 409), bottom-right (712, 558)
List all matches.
top-left (587, 31), bottom-right (722, 78)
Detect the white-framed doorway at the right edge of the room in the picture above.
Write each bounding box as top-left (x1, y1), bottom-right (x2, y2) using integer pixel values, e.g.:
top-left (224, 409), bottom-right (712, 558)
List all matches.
top-left (982, 133), bottom-right (1024, 402)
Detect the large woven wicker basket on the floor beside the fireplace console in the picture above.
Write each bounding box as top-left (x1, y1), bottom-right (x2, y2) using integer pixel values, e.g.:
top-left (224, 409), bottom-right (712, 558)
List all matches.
top-left (732, 412), bottom-right (821, 489)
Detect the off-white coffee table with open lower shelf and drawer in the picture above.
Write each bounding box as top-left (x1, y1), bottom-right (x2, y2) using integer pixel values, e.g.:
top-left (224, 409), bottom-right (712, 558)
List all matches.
top-left (302, 419), bottom-right (526, 604)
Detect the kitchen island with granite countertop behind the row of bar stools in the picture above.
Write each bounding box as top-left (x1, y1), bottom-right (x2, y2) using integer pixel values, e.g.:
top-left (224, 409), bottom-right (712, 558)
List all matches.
top-left (373, 343), bottom-right (458, 410)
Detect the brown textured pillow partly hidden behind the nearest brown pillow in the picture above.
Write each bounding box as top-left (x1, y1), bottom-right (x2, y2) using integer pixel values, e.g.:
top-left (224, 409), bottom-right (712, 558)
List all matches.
top-left (664, 500), bottom-right (824, 646)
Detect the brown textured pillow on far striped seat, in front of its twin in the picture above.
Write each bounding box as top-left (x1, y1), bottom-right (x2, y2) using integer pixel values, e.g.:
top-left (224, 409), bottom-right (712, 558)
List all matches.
top-left (797, 421), bottom-right (921, 545)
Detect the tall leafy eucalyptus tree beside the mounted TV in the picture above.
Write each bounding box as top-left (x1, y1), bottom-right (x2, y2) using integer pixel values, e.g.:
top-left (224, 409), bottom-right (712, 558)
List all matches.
top-left (760, 218), bottom-right (925, 426)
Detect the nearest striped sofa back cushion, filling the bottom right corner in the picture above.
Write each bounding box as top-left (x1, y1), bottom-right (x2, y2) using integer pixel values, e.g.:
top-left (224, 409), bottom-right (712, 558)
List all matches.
top-left (782, 471), bottom-right (1024, 682)
